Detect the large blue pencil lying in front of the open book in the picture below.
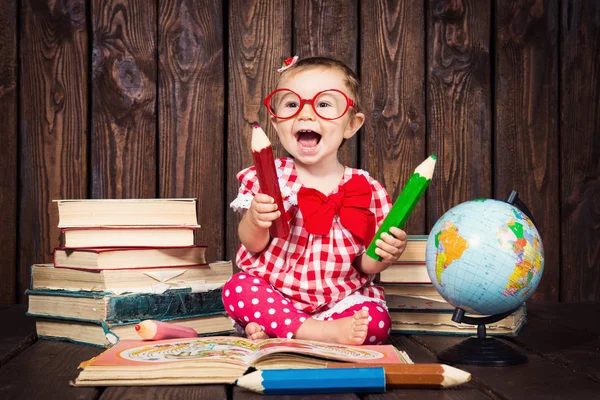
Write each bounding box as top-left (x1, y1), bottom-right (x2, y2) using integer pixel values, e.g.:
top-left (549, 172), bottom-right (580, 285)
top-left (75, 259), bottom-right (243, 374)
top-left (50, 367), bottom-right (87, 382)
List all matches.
top-left (236, 367), bottom-right (385, 394)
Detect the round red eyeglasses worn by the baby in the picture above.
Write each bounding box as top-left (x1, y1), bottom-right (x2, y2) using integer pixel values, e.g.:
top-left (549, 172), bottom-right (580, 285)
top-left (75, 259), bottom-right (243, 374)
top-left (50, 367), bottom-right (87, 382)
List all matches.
top-left (264, 88), bottom-right (356, 120)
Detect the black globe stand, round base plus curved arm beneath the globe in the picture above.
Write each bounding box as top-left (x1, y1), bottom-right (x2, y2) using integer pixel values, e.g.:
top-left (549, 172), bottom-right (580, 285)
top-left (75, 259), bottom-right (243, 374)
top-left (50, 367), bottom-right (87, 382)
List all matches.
top-left (438, 307), bottom-right (527, 367)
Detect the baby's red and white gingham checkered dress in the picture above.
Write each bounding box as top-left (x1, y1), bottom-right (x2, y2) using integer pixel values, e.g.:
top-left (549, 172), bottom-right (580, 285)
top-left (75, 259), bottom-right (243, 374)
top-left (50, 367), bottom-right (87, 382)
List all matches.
top-left (231, 158), bottom-right (391, 316)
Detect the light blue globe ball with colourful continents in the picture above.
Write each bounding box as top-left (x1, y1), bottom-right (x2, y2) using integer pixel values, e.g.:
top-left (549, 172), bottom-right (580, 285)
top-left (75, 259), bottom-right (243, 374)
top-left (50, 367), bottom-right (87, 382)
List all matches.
top-left (426, 199), bottom-right (544, 315)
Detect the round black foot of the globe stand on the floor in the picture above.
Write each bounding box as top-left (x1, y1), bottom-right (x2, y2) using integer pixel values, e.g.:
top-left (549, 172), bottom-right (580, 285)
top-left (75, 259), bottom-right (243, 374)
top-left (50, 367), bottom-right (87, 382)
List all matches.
top-left (438, 337), bottom-right (527, 367)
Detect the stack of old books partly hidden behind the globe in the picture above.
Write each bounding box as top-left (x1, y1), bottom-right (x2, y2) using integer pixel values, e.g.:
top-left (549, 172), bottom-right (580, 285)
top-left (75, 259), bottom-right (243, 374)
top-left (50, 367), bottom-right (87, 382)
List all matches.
top-left (378, 235), bottom-right (526, 336)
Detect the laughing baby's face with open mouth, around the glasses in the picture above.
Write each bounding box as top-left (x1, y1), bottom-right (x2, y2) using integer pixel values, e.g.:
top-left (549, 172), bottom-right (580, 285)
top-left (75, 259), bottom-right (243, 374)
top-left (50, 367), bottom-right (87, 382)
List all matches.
top-left (271, 68), bottom-right (365, 166)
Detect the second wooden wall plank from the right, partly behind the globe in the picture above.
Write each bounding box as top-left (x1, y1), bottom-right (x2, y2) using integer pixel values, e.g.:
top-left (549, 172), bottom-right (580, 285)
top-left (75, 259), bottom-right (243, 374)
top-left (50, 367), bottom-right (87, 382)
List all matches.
top-left (493, 1), bottom-right (560, 300)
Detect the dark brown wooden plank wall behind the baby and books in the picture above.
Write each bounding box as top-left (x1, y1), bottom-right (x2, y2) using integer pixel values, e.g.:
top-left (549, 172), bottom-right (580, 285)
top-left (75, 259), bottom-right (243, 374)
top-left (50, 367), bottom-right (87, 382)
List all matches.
top-left (0, 0), bottom-right (600, 304)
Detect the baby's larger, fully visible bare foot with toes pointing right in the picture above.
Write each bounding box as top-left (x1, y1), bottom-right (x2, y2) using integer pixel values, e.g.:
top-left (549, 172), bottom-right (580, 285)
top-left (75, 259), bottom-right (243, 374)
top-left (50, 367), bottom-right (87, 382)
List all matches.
top-left (296, 310), bottom-right (369, 345)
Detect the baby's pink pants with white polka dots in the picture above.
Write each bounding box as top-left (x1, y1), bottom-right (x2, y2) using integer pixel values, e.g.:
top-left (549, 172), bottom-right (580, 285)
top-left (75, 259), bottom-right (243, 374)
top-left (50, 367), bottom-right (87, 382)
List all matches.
top-left (222, 272), bottom-right (391, 344)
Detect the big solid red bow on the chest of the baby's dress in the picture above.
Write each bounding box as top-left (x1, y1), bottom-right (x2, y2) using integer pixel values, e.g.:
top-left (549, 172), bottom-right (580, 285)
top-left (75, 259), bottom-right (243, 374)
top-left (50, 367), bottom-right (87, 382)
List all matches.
top-left (298, 175), bottom-right (375, 244)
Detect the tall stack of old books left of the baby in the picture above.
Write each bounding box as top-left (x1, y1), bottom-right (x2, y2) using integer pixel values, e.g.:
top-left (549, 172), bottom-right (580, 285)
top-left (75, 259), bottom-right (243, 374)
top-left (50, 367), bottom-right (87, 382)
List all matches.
top-left (27, 199), bottom-right (232, 347)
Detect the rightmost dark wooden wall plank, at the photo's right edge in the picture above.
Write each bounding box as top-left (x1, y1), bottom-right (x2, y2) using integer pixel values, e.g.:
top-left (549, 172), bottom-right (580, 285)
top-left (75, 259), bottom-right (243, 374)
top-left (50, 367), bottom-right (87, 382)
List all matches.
top-left (555, 1), bottom-right (600, 300)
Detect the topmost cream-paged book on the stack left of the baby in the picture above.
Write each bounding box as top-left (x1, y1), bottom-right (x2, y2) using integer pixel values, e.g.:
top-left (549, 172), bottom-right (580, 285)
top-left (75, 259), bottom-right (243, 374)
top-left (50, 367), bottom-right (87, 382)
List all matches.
top-left (54, 199), bottom-right (198, 228)
